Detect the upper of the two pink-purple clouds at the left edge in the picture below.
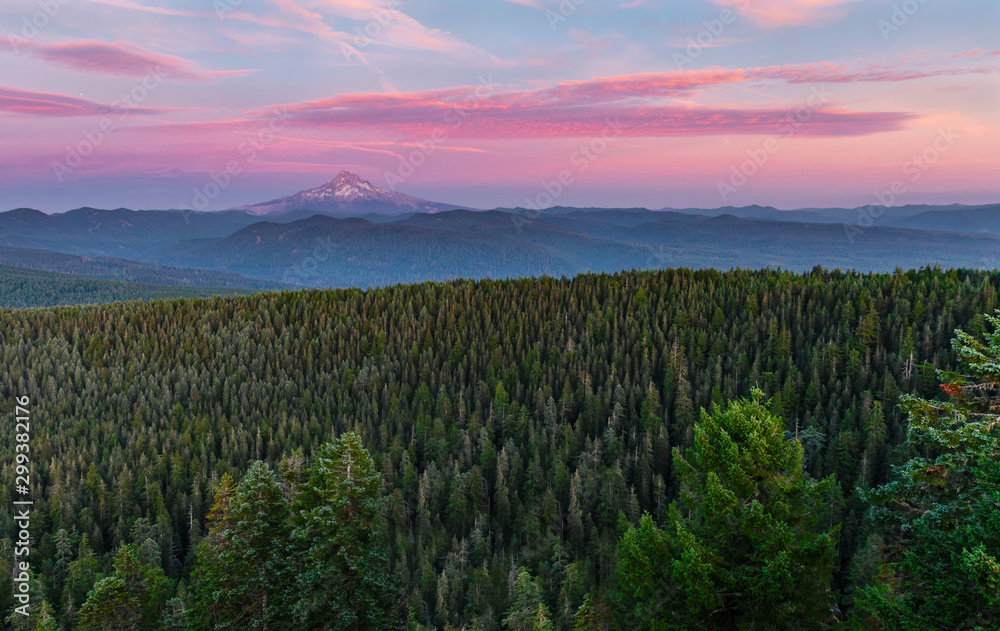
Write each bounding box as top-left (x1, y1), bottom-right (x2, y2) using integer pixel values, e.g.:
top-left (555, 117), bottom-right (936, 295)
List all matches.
top-left (5, 40), bottom-right (252, 81)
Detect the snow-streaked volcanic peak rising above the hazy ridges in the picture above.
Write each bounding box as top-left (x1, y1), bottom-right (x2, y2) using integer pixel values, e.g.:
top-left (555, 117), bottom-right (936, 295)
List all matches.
top-left (232, 171), bottom-right (470, 215)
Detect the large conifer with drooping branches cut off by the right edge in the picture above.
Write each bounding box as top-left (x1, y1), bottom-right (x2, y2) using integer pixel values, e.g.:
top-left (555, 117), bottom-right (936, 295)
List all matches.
top-left (858, 313), bottom-right (1000, 631)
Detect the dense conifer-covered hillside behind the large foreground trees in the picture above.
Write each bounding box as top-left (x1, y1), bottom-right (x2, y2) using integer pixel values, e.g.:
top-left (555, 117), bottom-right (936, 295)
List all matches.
top-left (0, 269), bottom-right (1000, 629)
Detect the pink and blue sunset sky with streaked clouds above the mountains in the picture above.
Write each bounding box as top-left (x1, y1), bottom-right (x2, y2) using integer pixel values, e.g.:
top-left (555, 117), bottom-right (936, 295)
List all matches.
top-left (0, 0), bottom-right (1000, 212)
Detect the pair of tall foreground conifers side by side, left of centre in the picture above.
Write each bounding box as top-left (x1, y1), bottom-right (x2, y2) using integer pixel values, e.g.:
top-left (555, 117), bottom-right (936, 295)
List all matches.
top-left (191, 433), bottom-right (405, 630)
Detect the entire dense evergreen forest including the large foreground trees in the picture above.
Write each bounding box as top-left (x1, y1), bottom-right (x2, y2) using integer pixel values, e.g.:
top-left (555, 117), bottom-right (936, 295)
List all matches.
top-left (0, 268), bottom-right (1000, 631)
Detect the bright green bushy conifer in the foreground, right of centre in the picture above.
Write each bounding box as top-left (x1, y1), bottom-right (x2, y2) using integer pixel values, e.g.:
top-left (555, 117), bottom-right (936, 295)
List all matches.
top-left (616, 391), bottom-right (836, 631)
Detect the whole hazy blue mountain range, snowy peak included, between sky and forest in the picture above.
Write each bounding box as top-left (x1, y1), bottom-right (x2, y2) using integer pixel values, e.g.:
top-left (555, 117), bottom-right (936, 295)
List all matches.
top-left (0, 196), bottom-right (1000, 288)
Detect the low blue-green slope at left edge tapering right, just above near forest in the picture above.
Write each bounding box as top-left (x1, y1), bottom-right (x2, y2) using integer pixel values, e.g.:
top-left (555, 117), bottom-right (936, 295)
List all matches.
top-left (0, 265), bottom-right (253, 309)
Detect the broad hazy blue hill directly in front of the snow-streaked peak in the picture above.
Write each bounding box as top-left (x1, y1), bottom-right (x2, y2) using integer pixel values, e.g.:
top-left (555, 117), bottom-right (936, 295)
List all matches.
top-left (158, 215), bottom-right (576, 287)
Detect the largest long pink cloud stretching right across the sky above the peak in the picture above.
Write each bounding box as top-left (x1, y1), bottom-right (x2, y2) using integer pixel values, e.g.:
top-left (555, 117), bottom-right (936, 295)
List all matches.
top-left (253, 55), bottom-right (1000, 138)
